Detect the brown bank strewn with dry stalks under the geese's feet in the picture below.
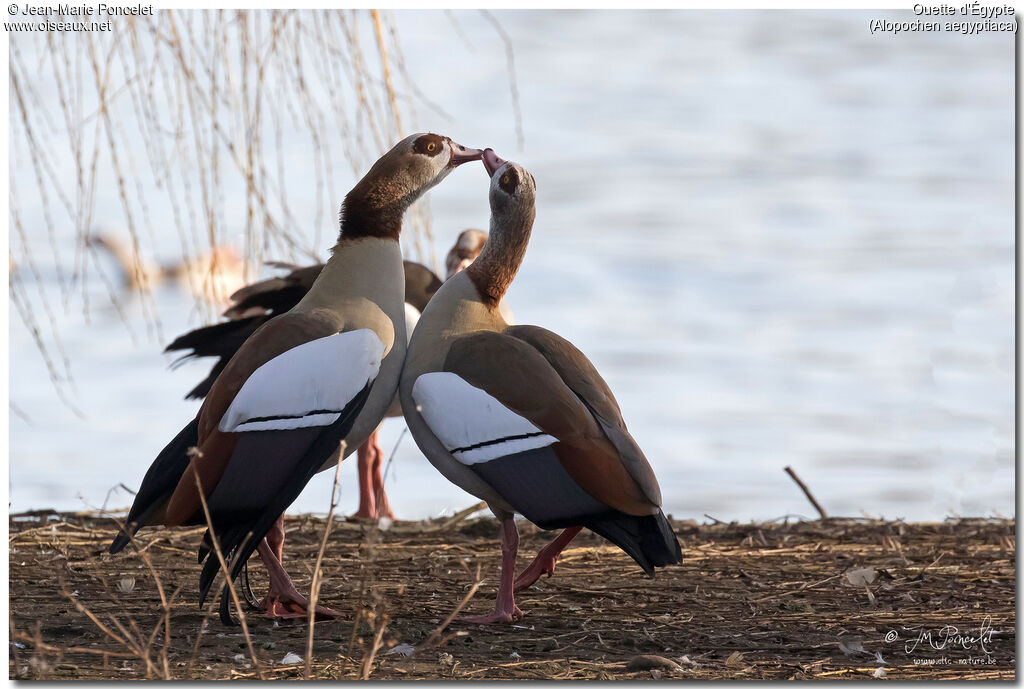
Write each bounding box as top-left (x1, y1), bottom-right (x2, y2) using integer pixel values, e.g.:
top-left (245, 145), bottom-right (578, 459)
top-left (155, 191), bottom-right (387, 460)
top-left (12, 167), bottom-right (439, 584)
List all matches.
top-left (9, 513), bottom-right (1016, 680)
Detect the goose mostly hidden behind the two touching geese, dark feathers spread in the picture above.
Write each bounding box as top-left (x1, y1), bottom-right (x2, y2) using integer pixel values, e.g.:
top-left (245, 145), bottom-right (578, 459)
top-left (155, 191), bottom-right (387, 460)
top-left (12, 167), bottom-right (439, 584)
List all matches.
top-left (164, 229), bottom-right (487, 519)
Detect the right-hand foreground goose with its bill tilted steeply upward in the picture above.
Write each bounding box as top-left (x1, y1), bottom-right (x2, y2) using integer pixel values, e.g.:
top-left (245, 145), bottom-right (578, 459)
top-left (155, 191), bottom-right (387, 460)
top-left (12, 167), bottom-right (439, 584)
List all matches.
top-left (399, 148), bottom-right (682, 622)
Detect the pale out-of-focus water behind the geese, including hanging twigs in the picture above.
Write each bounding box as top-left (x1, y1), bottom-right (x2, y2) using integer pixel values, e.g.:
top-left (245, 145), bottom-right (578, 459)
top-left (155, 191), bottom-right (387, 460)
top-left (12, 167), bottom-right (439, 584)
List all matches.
top-left (9, 10), bottom-right (1015, 520)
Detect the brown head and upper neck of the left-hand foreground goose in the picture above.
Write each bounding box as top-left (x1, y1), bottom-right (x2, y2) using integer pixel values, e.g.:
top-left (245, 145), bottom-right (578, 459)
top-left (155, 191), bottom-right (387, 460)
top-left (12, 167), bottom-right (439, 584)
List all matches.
top-left (341, 133), bottom-right (483, 239)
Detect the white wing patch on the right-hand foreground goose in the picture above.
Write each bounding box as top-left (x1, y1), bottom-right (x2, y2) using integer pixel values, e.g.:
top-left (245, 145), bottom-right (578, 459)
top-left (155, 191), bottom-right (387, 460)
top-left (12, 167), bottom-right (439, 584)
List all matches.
top-left (413, 372), bottom-right (558, 465)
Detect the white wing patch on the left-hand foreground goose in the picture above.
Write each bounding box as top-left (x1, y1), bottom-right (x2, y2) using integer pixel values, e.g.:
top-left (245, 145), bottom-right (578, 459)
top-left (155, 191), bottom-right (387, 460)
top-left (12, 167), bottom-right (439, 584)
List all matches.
top-left (220, 330), bottom-right (386, 433)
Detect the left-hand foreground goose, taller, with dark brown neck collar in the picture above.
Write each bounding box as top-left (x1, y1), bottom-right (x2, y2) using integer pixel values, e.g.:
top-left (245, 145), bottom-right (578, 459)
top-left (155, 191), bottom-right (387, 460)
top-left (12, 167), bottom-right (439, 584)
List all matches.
top-left (111, 134), bottom-right (481, 623)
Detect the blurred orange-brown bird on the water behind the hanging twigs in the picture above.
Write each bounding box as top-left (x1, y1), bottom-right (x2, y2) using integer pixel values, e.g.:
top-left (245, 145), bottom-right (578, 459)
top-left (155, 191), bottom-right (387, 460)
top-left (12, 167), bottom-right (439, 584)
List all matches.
top-left (86, 232), bottom-right (246, 304)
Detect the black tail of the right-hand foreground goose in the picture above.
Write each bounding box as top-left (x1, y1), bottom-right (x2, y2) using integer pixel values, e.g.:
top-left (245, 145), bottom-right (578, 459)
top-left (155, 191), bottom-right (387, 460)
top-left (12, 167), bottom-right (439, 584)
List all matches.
top-left (583, 510), bottom-right (683, 576)
